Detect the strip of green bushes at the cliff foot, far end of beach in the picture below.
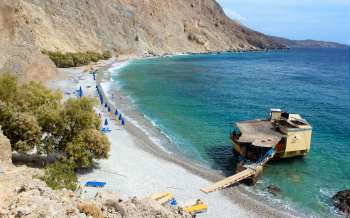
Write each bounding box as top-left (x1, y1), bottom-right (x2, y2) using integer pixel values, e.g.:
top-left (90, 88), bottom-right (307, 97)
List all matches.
top-left (42, 50), bottom-right (112, 68)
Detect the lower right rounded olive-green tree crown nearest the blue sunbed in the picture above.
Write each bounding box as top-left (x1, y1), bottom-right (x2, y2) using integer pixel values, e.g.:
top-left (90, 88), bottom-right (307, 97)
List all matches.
top-left (65, 129), bottom-right (110, 168)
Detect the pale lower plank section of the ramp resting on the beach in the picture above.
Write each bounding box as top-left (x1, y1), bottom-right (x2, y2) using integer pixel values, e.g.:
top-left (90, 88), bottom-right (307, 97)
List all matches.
top-left (201, 168), bottom-right (256, 194)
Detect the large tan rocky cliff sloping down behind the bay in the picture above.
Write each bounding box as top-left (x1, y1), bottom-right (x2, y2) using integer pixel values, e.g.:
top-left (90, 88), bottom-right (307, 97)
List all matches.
top-left (0, 0), bottom-right (284, 79)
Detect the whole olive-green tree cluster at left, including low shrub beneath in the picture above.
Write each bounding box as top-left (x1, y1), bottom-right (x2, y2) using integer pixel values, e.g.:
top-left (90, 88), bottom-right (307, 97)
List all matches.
top-left (0, 74), bottom-right (110, 188)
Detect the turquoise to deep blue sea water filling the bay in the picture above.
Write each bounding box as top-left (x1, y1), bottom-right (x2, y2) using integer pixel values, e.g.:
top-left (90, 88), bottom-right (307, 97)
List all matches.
top-left (115, 49), bottom-right (350, 216)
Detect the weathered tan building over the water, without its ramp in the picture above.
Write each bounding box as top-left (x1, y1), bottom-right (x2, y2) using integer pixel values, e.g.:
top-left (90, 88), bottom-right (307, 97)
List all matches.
top-left (231, 109), bottom-right (312, 161)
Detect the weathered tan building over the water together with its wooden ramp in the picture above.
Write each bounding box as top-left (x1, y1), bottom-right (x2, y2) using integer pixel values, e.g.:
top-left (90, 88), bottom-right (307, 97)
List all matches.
top-left (201, 109), bottom-right (312, 193)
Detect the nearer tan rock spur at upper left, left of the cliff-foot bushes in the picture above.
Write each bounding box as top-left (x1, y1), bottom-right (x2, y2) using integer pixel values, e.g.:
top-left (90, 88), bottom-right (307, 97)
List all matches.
top-left (0, 0), bottom-right (57, 81)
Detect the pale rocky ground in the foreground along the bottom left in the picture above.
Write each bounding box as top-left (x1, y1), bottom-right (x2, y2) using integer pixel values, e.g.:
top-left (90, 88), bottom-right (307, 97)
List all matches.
top-left (0, 167), bottom-right (191, 218)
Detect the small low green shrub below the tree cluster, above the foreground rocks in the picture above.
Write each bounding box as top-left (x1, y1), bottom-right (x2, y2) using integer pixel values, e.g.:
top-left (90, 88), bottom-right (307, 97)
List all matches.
top-left (39, 161), bottom-right (78, 191)
